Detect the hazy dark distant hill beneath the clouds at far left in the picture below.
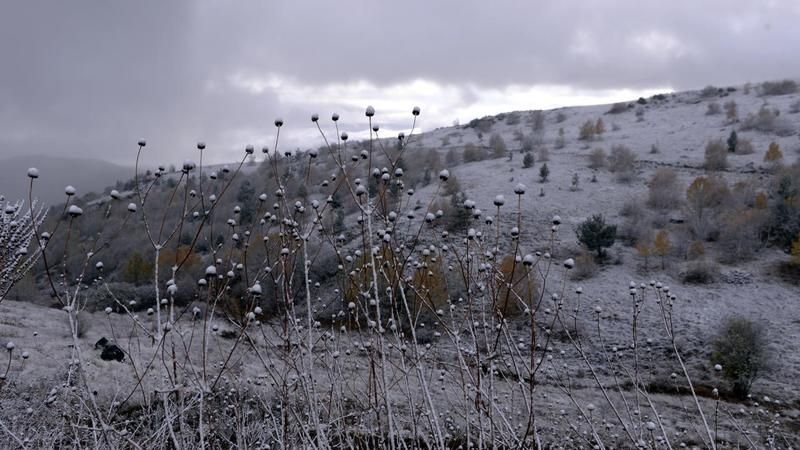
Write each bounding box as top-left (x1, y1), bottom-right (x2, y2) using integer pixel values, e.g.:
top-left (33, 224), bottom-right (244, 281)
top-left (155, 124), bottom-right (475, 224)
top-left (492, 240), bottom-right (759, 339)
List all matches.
top-left (0, 155), bottom-right (133, 205)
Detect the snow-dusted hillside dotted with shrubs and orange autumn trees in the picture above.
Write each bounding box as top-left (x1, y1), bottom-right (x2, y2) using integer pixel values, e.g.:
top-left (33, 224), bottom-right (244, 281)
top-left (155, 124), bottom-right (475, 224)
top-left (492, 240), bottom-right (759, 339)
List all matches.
top-left (0, 80), bottom-right (800, 448)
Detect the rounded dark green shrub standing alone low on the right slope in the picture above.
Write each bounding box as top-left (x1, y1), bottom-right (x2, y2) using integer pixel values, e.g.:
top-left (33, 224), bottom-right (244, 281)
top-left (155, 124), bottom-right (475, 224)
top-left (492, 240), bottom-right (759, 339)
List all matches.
top-left (711, 316), bottom-right (769, 399)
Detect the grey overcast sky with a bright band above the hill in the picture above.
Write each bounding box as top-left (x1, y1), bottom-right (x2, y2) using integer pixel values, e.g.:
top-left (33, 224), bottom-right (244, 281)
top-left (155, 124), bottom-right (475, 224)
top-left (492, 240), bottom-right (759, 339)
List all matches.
top-left (0, 0), bottom-right (800, 164)
